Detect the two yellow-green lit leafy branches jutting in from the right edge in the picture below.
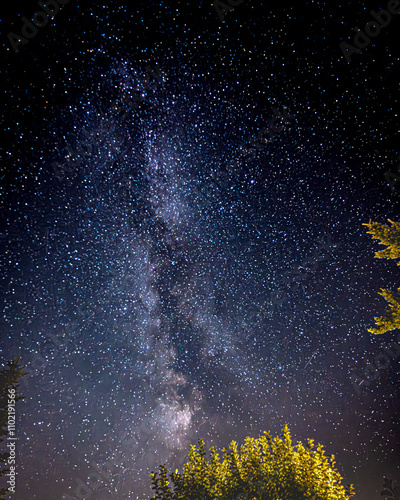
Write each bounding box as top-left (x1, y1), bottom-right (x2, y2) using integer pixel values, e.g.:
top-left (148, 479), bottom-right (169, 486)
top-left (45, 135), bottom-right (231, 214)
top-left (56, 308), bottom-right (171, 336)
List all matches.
top-left (363, 219), bottom-right (400, 335)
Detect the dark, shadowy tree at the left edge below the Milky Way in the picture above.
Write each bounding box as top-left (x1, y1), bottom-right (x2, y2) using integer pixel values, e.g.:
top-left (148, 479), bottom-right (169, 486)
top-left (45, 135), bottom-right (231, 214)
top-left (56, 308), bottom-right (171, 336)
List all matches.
top-left (0, 356), bottom-right (26, 498)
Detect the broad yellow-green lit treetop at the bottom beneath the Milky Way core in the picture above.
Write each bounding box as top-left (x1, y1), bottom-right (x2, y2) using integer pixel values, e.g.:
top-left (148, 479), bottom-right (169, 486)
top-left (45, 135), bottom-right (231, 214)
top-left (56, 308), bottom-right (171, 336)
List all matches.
top-left (151, 425), bottom-right (354, 500)
